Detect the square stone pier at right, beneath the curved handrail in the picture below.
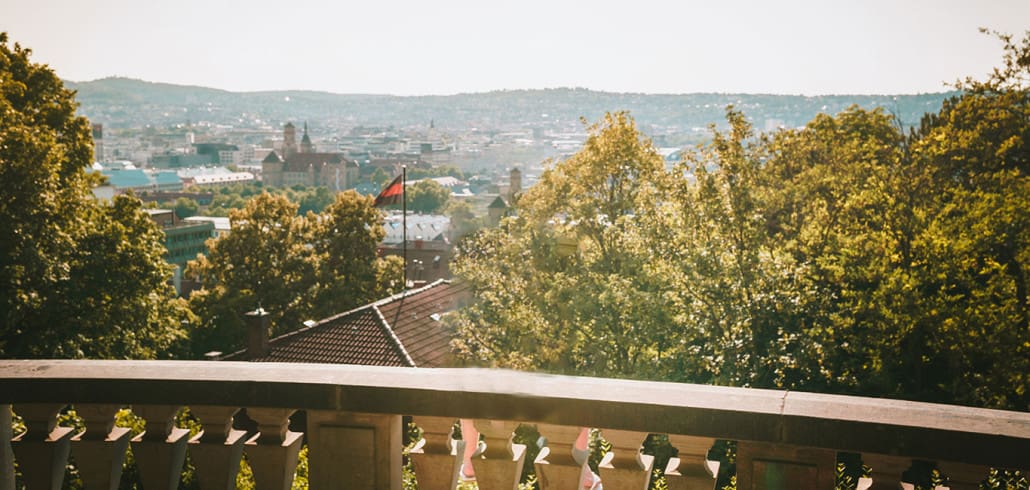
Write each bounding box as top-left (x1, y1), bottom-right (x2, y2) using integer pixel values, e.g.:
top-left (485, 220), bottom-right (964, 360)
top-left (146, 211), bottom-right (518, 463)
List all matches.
top-left (736, 441), bottom-right (836, 490)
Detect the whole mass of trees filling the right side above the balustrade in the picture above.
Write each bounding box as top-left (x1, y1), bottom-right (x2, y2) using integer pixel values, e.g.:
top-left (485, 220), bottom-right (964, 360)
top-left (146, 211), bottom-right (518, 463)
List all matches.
top-left (453, 31), bottom-right (1030, 410)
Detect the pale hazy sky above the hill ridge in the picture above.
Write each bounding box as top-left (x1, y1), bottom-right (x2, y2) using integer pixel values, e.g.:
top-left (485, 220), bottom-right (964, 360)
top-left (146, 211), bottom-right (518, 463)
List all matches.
top-left (0, 0), bottom-right (1030, 95)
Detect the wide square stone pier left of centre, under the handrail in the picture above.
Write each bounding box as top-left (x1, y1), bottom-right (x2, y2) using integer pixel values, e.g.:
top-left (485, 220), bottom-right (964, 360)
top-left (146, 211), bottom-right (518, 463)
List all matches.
top-left (302, 410), bottom-right (403, 490)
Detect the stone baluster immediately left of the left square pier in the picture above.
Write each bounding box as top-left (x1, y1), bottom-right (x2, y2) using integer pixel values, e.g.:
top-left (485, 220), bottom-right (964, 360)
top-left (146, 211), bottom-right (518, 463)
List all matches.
top-left (245, 409), bottom-right (300, 490)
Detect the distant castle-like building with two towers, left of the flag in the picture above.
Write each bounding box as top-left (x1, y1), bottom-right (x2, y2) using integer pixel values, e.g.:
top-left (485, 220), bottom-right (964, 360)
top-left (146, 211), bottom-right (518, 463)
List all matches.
top-left (262, 123), bottom-right (358, 190)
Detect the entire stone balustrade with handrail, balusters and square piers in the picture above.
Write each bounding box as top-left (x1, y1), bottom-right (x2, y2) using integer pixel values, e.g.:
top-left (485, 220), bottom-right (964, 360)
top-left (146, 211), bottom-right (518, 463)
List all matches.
top-left (0, 360), bottom-right (1030, 490)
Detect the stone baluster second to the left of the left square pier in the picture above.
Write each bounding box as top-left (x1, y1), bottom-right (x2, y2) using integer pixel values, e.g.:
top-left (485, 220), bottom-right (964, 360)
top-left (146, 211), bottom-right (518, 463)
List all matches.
top-left (190, 406), bottom-right (247, 490)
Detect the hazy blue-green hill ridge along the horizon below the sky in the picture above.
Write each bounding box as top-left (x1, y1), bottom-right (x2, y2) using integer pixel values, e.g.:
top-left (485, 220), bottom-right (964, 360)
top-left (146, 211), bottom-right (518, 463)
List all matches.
top-left (65, 78), bottom-right (954, 133)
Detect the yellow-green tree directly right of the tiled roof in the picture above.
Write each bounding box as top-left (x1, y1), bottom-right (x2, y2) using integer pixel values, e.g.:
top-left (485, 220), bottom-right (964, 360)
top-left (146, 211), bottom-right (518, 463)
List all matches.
top-left (454, 113), bottom-right (673, 377)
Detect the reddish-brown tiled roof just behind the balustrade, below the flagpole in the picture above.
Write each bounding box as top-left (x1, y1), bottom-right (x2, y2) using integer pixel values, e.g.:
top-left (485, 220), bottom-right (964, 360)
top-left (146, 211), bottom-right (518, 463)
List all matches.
top-left (226, 280), bottom-right (470, 368)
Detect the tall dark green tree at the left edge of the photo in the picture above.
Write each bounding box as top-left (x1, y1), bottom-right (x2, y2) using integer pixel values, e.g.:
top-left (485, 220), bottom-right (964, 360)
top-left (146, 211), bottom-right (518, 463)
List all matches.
top-left (0, 34), bottom-right (190, 358)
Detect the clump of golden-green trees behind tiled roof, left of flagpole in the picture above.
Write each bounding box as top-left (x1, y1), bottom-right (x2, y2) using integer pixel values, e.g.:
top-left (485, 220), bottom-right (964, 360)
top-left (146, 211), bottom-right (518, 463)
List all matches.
top-left (186, 190), bottom-right (402, 356)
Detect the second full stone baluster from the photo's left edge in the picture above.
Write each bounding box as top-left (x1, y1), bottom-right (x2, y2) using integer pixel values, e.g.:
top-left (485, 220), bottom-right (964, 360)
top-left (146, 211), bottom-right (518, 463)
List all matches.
top-left (72, 404), bottom-right (132, 490)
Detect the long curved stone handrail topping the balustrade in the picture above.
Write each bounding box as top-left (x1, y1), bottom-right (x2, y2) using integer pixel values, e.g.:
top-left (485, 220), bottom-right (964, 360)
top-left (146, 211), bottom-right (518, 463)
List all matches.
top-left (0, 360), bottom-right (1030, 467)
